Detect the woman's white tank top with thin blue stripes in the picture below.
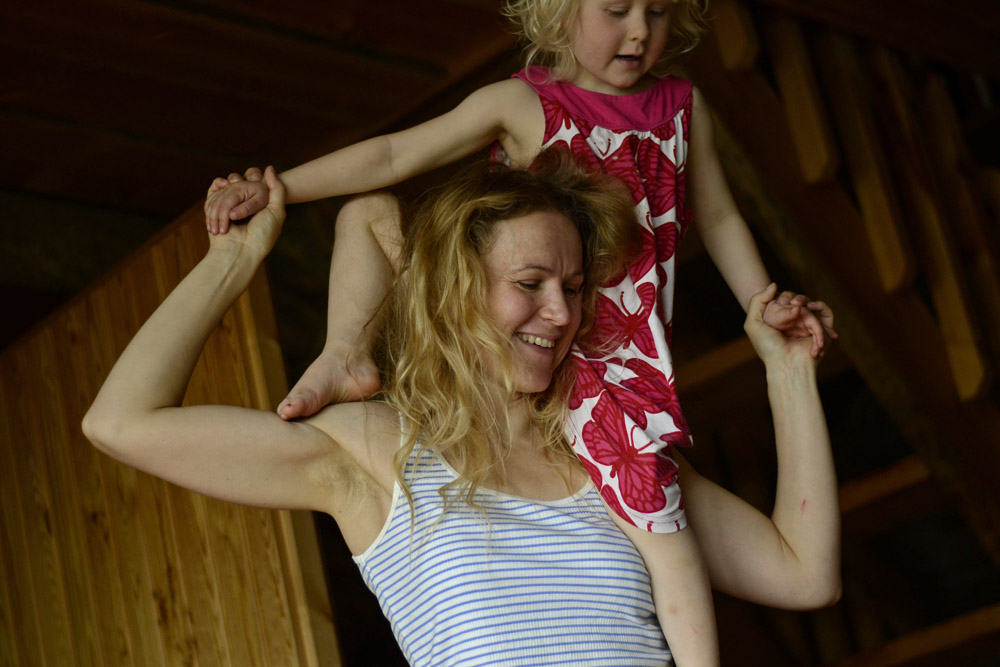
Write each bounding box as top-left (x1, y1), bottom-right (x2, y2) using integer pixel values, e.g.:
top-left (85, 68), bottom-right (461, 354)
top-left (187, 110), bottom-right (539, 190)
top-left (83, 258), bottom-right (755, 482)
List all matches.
top-left (354, 446), bottom-right (673, 667)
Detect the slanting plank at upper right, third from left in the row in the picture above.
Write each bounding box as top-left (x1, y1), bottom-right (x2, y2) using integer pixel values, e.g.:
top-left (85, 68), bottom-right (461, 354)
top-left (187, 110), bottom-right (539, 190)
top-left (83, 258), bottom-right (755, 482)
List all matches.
top-left (817, 31), bottom-right (914, 292)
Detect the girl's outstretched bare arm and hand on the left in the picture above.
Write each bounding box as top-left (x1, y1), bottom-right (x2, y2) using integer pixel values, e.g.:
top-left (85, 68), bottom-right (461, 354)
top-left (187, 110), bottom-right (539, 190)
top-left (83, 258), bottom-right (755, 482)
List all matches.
top-left (205, 79), bottom-right (544, 233)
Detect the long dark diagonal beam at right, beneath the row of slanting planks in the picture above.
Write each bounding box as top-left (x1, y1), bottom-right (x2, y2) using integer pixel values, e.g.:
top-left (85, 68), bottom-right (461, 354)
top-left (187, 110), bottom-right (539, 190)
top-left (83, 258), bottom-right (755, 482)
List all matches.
top-left (689, 27), bottom-right (1000, 562)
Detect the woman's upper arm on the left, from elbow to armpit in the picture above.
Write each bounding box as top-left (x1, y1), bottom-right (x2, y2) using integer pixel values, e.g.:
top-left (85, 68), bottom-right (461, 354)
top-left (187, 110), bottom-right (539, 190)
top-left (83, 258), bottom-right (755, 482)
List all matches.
top-left (85, 405), bottom-right (390, 513)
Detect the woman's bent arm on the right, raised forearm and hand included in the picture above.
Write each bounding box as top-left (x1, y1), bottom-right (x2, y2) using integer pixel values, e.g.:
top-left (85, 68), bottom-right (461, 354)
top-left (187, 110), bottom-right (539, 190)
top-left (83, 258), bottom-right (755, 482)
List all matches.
top-left (678, 285), bottom-right (841, 609)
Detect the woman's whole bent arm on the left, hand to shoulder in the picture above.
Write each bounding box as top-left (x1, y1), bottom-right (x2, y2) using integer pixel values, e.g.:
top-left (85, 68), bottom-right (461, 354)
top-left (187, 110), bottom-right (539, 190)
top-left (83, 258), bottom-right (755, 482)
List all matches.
top-left (83, 168), bottom-right (391, 528)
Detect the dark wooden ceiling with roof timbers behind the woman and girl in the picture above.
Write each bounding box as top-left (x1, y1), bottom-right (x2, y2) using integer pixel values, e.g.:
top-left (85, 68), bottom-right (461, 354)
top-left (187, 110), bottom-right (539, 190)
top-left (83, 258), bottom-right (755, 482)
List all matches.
top-left (0, 0), bottom-right (1000, 665)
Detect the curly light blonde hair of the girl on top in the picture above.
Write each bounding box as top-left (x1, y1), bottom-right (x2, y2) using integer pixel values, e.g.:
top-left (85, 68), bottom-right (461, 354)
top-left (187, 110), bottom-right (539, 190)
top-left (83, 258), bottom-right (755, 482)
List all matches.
top-left (501, 0), bottom-right (708, 81)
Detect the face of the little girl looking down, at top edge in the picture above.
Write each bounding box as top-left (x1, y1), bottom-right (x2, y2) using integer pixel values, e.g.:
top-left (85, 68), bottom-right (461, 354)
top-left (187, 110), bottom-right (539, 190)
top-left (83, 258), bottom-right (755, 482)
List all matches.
top-left (570, 0), bottom-right (674, 95)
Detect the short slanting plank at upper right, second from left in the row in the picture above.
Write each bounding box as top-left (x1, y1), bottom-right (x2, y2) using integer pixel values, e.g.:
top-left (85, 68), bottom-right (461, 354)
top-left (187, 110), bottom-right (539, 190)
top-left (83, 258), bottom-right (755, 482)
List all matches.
top-left (763, 11), bottom-right (840, 183)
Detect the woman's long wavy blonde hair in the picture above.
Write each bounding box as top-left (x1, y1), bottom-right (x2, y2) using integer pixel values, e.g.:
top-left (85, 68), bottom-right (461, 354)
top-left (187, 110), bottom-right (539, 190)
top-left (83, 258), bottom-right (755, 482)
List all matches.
top-left (383, 149), bottom-right (638, 506)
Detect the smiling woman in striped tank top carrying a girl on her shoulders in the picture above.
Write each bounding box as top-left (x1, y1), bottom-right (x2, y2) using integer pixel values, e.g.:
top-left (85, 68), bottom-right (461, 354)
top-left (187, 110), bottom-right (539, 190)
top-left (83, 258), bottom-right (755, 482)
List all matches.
top-left (84, 153), bottom-right (839, 665)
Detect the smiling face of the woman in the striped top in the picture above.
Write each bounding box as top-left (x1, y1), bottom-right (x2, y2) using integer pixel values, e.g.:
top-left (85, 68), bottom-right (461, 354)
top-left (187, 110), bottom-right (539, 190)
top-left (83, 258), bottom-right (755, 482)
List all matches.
top-left (483, 211), bottom-right (584, 393)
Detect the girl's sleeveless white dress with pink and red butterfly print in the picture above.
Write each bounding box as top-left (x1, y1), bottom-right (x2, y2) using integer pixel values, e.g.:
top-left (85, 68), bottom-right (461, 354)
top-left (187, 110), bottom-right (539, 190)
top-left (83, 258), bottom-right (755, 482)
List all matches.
top-left (517, 72), bottom-right (691, 532)
